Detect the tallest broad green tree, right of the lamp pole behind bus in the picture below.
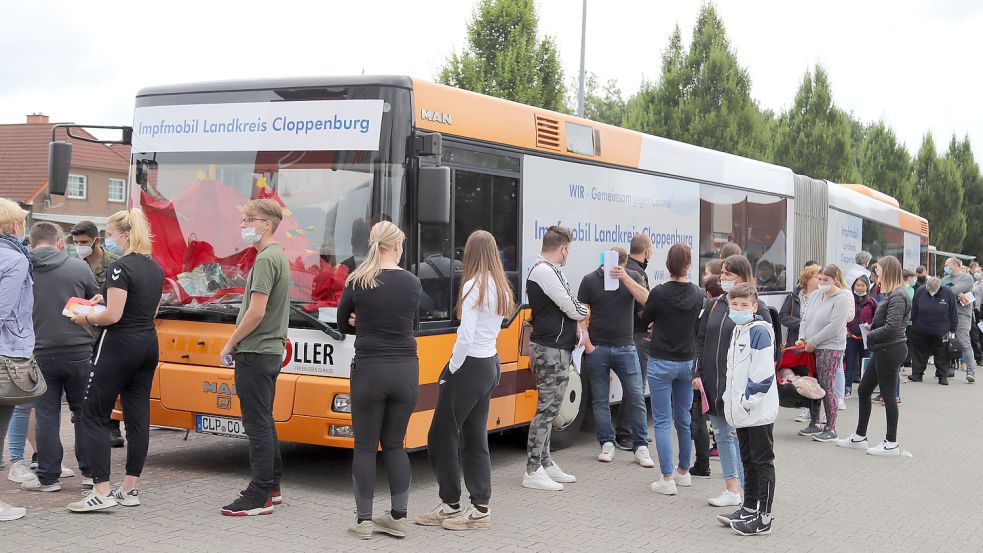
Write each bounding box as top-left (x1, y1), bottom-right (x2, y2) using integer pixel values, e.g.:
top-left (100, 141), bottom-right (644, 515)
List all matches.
top-left (624, 5), bottom-right (768, 159)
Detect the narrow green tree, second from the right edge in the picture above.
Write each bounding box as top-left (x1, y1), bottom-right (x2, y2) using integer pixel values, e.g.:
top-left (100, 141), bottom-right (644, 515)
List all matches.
top-left (914, 133), bottom-right (966, 252)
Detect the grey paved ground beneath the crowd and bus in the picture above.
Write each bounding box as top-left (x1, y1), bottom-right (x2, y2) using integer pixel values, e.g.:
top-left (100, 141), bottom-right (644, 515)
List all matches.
top-left (0, 370), bottom-right (983, 552)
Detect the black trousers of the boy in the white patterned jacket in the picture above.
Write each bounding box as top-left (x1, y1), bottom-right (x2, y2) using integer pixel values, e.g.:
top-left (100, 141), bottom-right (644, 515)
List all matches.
top-left (737, 424), bottom-right (775, 515)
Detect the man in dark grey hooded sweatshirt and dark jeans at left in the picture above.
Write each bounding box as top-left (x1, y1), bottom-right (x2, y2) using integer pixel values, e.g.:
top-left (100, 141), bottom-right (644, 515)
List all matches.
top-left (21, 221), bottom-right (99, 492)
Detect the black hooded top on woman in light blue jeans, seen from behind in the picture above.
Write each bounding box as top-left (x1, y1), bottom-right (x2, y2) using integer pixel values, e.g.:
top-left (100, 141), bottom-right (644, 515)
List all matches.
top-left (641, 281), bottom-right (703, 361)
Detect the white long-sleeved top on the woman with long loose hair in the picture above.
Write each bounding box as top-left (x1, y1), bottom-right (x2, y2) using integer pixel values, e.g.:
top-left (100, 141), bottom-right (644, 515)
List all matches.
top-left (450, 278), bottom-right (502, 372)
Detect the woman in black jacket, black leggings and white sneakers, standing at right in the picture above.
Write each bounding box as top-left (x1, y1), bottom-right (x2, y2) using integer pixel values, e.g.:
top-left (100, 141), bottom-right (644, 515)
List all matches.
top-left (836, 256), bottom-right (911, 456)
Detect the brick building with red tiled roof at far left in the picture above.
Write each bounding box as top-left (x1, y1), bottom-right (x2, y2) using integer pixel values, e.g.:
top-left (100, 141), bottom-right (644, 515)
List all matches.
top-left (0, 114), bottom-right (130, 230)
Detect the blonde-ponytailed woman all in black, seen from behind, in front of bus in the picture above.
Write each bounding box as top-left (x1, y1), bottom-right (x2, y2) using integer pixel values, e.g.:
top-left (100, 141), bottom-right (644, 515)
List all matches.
top-left (338, 221), bottom-right (422, 539)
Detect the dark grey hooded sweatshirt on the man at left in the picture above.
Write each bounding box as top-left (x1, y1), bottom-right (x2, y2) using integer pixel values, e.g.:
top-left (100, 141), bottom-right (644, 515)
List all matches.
top-left (31, 247), bottom-right (99, 355)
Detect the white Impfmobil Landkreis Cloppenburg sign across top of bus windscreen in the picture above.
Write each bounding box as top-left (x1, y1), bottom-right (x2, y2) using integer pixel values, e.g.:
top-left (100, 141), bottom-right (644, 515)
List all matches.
top-left (133, 100), bottom-right (383, 152)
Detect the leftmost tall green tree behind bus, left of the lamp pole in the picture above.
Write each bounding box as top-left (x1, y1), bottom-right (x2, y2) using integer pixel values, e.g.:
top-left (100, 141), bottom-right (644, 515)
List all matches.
top-left (437, 0), bottom-right (565, 111)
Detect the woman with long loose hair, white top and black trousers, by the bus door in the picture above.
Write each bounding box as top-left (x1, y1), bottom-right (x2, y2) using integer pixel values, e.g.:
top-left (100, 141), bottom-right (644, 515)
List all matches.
top-left (416, 230), bottom-right (515, 530)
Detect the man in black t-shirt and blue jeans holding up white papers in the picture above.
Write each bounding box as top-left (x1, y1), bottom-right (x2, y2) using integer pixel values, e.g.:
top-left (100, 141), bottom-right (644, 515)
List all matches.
top-left (577, 248), bottom-right (655, 468)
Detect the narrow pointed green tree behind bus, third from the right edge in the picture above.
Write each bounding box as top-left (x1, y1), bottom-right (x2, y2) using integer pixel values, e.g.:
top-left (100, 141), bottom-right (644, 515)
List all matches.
top-left (857, 121), bottom-right (918, 213)
